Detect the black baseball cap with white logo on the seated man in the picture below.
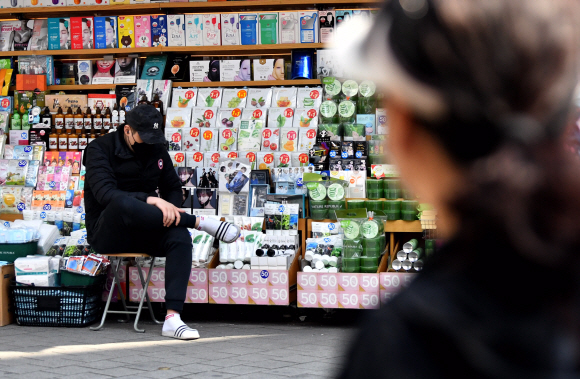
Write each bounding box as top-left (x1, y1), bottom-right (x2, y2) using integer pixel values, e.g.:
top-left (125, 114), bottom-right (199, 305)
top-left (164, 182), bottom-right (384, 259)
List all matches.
top-left (122, 104), bottom-right (165, 145)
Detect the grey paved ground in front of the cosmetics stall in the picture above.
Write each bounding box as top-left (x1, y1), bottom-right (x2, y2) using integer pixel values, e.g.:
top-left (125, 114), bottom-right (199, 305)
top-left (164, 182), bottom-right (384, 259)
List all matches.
top-left (0, 307), bottom-right (362, 379)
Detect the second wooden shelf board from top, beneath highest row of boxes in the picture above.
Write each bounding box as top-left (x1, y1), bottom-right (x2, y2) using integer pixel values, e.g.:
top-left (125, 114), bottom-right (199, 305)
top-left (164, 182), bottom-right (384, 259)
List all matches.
top-left (0, 43), bottom-right (324, 58)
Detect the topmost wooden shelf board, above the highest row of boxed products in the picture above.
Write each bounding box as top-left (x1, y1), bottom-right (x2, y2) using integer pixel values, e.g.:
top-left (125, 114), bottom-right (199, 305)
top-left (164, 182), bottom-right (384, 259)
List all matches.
top-left (0, 0), bottom-right (380, 19)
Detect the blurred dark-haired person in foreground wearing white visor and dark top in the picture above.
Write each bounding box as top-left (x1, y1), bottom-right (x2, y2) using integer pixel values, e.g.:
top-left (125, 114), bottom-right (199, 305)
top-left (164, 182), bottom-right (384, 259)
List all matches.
top-left (338, 0), bottom-right (580, 379)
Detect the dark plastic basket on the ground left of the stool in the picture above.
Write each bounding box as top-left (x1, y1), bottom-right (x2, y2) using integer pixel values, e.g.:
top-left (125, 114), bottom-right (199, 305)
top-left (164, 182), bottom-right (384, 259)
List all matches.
top-left (10, 282), bottom-right (103, 327)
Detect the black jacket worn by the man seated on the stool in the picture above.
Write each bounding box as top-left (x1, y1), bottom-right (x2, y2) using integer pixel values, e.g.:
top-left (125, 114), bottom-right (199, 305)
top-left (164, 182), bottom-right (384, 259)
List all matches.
top-left (83, 132), bottom-right (182, 243)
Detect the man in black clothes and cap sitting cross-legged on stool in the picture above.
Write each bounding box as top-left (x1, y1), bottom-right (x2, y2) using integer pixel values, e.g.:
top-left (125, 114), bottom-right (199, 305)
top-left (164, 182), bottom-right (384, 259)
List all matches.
top-left (83, 104), bottom-right (240, 339)
